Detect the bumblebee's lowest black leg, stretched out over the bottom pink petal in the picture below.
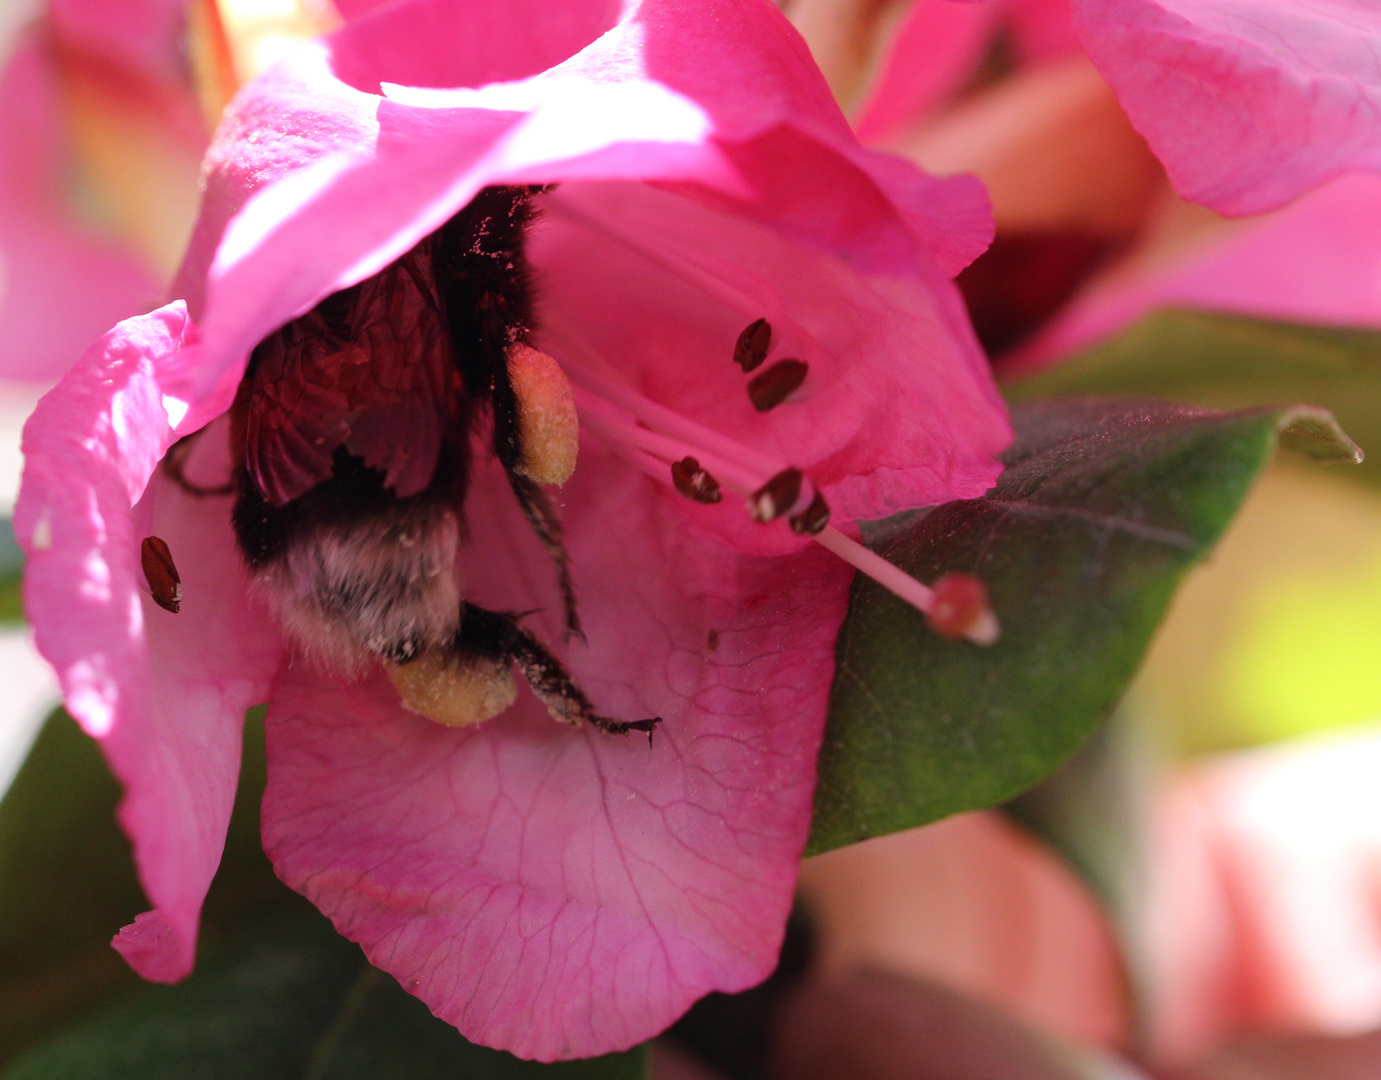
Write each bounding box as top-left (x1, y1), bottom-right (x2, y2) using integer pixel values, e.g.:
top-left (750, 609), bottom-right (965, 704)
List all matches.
top-left (456, 604), bottom-right (661, 744)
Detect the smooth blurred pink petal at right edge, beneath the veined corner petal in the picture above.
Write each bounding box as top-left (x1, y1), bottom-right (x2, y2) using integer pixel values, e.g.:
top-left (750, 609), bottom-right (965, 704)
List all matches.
top-left (1011, 174), bottom-right (1381, 369)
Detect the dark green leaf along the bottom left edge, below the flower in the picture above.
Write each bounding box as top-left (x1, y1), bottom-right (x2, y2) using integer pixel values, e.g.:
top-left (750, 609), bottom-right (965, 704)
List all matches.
top-left (4, 920), bottom-right (646, 1080)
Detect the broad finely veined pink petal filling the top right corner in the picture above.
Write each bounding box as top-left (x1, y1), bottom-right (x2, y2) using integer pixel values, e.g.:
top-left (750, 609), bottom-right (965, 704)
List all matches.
top-left (1074, 0), bottom-right (1381, 215)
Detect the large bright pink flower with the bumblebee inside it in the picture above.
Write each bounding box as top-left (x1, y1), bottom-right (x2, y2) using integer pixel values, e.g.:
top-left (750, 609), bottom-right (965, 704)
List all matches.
top-left (15, 0), bottom-right (1008, 1059)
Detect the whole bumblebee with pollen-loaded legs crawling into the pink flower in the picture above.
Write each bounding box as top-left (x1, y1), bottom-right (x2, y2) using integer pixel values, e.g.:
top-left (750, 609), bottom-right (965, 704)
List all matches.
top-left (170, 186), bottom-right (659, 737)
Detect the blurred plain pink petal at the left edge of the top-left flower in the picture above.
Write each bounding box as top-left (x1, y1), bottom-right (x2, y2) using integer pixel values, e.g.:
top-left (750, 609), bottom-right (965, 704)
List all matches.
top-left (0, 41), bottom-right (160, 383)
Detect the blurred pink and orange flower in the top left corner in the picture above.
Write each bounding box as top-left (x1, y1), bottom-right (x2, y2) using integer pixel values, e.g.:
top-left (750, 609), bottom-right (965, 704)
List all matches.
top-left (0, 0), bottom-right (206, 381)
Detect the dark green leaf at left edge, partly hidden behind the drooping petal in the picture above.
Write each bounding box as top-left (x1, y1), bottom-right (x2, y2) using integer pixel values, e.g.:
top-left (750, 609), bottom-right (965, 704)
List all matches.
top-left (0, 710), bottom-right (312, 1066)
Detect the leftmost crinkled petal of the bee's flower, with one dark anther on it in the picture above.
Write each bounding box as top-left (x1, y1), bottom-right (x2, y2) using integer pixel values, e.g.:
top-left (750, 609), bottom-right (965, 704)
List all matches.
top-left (15, 304), bottom-right (278, 981)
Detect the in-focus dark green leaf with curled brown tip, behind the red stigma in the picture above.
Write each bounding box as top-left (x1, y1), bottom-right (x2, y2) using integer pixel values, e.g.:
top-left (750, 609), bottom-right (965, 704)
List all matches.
top-left (808, 399), bottom-right (1356, 854)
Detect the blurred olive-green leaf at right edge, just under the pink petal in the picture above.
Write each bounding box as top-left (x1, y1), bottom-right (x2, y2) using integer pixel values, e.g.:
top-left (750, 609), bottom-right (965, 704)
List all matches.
top-left (1004, 309), bottom-right (1381, 485)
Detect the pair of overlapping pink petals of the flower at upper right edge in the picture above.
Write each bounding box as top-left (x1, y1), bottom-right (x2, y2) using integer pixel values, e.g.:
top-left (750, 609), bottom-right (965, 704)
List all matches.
top-left (1015, 0), bottom-right (1381, 365)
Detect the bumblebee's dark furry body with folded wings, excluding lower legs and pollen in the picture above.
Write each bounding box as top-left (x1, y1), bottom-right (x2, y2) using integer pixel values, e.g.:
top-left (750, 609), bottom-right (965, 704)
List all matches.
top-left (233, 188), bottom-right (541, 673)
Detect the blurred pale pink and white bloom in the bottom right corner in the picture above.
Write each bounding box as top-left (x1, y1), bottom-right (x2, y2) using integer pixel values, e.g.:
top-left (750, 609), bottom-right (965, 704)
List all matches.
top-left (1148, 726), bottom-right (1381, 1061)
